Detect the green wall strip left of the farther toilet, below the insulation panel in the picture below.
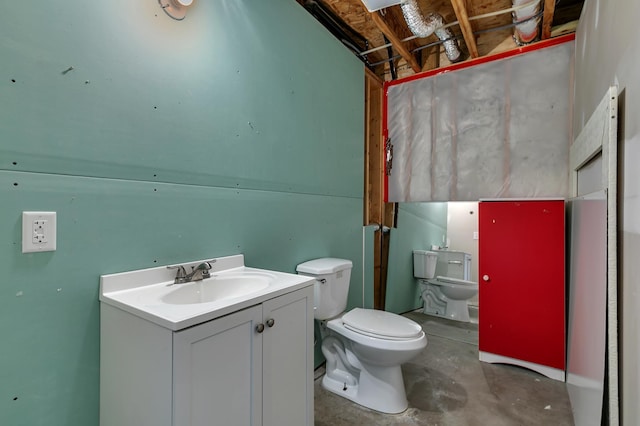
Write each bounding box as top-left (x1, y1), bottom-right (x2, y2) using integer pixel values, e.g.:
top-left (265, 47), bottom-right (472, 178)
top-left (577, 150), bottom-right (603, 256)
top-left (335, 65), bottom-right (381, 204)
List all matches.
top-left (385, 202), bottom-right (448, 313)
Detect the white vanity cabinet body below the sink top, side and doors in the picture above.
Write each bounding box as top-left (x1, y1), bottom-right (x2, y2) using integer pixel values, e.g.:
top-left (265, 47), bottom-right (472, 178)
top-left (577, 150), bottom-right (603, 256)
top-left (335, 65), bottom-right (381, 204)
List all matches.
top-left (100, 285), bottom-right (313, 426)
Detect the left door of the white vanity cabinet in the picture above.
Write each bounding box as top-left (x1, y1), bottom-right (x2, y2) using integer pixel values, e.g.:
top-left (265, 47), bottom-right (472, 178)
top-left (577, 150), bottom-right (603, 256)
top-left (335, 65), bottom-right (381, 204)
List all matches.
top-left (173, 305), bottom-right (263, 426)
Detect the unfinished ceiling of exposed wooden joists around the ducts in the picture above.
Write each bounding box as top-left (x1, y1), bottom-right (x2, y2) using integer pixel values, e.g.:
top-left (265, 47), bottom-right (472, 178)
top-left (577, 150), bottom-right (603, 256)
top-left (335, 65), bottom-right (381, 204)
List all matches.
top-left (295, 0), bottom-right (584, 80)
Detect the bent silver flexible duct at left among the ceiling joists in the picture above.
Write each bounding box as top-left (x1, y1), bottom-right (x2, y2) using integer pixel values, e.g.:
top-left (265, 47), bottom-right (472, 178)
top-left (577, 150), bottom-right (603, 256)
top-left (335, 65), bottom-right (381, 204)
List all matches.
top-left (400, 0), bottom-right (462, 62)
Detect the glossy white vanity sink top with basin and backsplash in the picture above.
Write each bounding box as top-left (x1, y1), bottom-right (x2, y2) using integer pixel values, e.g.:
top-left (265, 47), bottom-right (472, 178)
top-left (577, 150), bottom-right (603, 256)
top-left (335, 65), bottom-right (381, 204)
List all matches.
top-left (100, 254), bottom-right (314, 331)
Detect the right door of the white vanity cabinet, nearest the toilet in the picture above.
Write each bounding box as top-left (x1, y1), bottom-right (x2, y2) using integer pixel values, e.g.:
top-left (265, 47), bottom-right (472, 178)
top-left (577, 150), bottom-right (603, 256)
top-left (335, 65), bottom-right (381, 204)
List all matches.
top-left (262, 287), bottom-right (313, 426)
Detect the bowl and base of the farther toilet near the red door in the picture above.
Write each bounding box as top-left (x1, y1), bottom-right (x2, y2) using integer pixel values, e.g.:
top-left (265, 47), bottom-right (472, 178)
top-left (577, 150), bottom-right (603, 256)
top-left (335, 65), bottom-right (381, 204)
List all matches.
top-left (420, 276), bottom-right (478, 322)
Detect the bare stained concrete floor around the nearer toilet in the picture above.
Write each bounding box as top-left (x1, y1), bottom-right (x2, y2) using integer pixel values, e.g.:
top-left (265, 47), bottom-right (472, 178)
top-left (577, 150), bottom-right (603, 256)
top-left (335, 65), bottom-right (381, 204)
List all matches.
top-left (314, 312), bottom-right (574, 426)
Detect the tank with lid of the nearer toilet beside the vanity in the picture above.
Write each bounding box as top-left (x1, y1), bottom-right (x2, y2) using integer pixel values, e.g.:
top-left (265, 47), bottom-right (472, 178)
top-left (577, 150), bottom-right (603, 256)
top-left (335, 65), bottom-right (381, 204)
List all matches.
top-left (296, 257), bottom-right (353, 320)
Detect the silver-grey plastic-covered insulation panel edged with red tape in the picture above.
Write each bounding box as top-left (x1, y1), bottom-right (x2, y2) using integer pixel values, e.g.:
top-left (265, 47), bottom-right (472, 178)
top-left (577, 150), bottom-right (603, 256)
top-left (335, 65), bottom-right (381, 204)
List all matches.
top-left (387, 43), bottom-right (574, 202)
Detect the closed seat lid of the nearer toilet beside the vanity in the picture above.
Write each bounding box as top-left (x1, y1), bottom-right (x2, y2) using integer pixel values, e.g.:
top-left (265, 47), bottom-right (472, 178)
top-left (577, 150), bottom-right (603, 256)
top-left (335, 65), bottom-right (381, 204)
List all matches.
top-left (342, 308), bottom-right (422, 340)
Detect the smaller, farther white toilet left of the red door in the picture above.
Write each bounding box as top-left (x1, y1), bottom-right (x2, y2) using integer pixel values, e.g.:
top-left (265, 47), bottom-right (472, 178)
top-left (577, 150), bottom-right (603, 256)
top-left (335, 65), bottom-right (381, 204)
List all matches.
top-left (413, 250), bottom-right (478, 322)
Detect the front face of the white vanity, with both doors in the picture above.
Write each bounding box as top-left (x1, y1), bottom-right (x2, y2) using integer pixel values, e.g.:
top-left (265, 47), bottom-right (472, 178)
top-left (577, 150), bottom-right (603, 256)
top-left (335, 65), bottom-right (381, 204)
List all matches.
top-left (173, 287), bottom-right (313, 426)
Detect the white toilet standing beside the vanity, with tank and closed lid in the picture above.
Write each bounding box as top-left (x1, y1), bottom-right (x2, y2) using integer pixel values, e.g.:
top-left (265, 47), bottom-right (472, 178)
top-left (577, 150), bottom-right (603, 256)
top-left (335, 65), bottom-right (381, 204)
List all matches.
top-left (296, 258), bottom-right (427, 413)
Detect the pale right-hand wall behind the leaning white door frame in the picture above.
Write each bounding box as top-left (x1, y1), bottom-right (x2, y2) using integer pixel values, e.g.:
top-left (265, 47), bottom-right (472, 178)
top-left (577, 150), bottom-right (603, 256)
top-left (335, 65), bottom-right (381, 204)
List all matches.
top-left (573, 0), bottom-right (640, 426)
